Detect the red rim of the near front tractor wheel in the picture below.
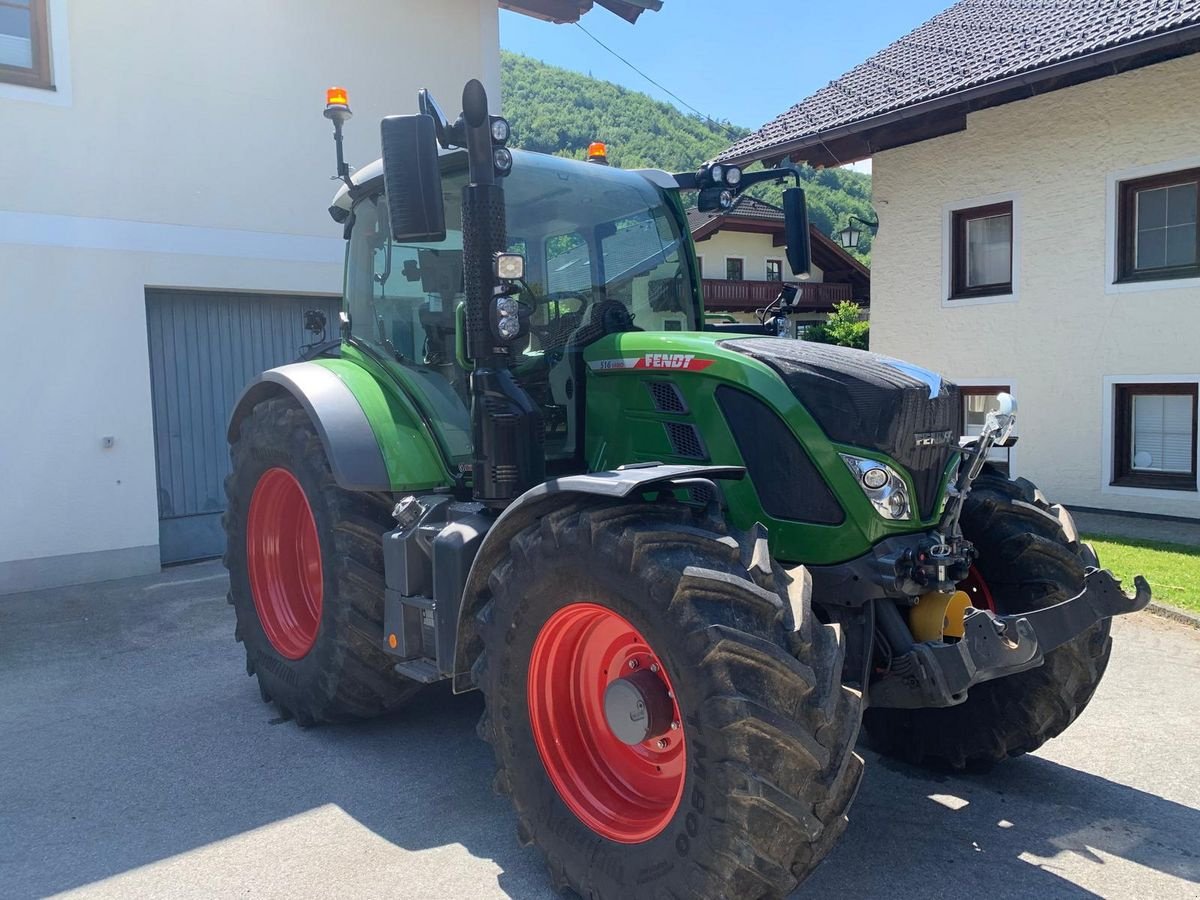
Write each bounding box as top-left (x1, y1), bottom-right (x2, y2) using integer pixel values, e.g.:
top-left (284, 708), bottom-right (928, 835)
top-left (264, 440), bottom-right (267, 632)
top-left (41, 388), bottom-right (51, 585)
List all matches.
top-left (527, 604), bottom-right (688, 844)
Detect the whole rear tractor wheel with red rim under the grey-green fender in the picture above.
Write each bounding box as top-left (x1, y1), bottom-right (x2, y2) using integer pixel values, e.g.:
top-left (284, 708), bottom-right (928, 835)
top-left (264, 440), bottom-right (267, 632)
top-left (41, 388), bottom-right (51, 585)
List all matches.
top-left (222, 397), bottom-right (420, 726)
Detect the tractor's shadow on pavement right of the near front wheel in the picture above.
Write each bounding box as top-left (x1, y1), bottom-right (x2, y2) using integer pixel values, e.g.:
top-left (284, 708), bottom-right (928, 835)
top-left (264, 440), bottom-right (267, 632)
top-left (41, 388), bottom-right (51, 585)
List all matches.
top-left (794, 746), bottom-right (1200, 900)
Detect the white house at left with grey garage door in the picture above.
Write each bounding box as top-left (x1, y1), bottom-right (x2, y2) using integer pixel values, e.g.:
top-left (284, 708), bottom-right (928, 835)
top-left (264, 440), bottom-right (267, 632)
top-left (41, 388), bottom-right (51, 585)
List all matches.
top-left (0, 0), bottom-right (659, 593)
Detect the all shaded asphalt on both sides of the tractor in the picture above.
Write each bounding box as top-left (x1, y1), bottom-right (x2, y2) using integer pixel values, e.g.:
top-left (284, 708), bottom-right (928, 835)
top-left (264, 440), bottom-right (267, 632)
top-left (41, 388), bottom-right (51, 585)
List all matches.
top-left (0, 566), bottom-right (1200, 900)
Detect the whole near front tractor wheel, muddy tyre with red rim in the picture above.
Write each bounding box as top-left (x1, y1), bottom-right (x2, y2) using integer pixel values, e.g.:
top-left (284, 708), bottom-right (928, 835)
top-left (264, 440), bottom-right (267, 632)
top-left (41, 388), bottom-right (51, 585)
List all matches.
top-left (473, 500), bottom-right (862, 900)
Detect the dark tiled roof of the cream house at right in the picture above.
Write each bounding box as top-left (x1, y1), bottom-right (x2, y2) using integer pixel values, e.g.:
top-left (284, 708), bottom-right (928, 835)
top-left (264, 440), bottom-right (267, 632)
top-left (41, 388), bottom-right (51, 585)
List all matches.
top-left (720, 0), bottom-right (1200, 164)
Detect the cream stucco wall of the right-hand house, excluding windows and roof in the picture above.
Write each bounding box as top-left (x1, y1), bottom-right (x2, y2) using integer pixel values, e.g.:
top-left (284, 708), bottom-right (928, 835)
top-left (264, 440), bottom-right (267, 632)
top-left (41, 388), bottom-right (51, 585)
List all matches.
top-left (871, 56), bottom-right (1200, 517)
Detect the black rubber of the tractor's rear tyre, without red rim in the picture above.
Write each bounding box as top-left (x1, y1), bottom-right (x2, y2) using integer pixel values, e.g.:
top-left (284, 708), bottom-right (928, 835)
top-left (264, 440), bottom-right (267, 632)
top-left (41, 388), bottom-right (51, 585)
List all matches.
top-left (222, 397), bottom-right (420, 725)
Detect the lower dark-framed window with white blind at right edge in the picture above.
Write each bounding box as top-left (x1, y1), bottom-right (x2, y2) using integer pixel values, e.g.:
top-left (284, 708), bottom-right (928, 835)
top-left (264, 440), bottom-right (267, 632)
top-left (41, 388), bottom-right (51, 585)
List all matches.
top-left (1111, 383), bottom-right (1198, 491)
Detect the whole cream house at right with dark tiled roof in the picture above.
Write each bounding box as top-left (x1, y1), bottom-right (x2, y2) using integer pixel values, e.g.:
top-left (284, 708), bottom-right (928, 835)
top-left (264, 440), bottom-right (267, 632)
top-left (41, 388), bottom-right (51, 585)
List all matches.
top-left (724, 0), bottom-right (1200, 518)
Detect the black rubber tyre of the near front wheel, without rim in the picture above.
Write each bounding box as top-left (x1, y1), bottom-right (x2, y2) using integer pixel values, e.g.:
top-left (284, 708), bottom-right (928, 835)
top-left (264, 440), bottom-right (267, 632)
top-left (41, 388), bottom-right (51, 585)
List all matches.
top-left (474, 500), bottom-right (862, 900)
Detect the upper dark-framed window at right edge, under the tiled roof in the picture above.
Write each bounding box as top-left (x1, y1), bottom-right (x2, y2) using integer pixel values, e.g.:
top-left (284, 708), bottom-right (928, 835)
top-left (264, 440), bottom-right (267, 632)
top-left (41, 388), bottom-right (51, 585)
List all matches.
top-left (1117, 169), bottom-right (1200, 282)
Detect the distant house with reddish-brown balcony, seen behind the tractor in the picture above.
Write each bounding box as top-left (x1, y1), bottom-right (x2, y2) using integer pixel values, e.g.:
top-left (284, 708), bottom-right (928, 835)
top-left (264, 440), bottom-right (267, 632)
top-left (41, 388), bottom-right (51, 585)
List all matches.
top-left (688, 194), bottom-right (871, 337)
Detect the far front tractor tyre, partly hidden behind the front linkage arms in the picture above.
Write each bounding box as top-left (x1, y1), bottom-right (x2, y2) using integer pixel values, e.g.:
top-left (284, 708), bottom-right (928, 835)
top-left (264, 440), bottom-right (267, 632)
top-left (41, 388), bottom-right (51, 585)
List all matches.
top-left (863, 466), bottom-right (1112, 772)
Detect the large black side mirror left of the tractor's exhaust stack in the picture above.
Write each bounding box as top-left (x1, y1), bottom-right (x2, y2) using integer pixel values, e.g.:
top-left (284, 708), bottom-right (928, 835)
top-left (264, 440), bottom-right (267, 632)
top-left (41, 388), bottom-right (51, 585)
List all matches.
top-left (379, 115), bottom-right (446, 244)
